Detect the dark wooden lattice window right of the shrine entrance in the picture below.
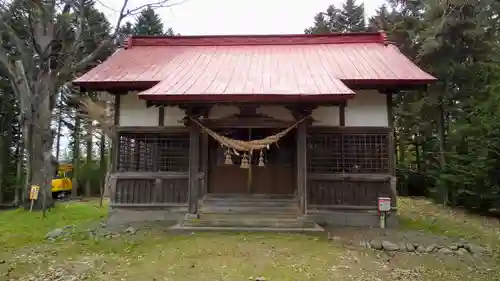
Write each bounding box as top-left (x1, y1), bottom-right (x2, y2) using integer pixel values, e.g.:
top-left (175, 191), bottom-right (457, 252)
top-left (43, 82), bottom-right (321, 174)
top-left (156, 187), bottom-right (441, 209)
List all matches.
top-left (307, 129), bottom-right (389, 174)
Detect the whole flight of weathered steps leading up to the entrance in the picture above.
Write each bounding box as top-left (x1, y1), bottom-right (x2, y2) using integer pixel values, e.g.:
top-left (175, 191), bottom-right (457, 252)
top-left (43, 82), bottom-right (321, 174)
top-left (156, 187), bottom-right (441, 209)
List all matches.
top-left (173, 195), bottom-right (323, 232)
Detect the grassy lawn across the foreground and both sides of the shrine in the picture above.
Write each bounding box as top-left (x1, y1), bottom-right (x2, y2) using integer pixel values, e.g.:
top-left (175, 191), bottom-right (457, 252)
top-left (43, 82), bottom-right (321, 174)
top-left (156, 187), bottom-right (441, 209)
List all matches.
top-left (0, 199), bottom-right (500, 281)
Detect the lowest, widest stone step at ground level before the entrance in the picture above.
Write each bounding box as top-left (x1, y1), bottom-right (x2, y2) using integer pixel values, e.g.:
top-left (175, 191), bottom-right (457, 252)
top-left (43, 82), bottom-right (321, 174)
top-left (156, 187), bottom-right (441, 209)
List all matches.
top-left (170, 224), bottom-right (324, 233)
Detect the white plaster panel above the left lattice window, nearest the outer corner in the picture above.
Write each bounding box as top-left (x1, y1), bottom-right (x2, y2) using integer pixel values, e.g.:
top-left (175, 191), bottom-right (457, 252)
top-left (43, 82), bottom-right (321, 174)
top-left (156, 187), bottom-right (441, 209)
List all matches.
top-left (119, 93), bottom-right (158, 127)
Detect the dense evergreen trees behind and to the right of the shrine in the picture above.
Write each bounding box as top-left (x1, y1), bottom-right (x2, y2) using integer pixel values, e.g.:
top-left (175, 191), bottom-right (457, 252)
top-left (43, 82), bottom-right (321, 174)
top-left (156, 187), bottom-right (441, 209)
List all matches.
top-left (306, 0), bottom-right (500, 211)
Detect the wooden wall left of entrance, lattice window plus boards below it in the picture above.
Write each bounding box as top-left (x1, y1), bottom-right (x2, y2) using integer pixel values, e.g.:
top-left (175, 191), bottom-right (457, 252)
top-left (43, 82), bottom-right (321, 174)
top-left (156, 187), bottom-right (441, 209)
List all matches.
top-left (111, 130), bottom-right (189, 206)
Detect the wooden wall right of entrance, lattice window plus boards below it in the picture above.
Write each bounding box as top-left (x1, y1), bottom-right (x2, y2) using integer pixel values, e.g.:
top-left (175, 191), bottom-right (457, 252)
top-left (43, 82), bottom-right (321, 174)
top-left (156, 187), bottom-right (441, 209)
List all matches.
top-left (307, 127), bottom-right (396, 209)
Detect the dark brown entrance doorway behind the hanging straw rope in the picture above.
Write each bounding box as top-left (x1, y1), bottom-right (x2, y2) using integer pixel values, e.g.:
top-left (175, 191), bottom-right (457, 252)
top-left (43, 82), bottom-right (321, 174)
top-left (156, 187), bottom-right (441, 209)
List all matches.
top-left (208, 128), bottom-right (296, 195)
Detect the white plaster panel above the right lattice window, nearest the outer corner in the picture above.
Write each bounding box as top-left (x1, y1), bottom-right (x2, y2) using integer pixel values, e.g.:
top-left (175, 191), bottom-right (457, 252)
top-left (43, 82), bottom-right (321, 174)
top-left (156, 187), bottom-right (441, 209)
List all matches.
top-left (345, 90), bottom-right (389, 127)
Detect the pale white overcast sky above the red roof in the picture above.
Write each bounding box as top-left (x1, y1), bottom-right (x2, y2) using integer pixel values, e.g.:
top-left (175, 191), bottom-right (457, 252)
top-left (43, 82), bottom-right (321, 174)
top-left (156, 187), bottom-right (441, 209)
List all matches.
top-left (96, 0), bottom-right (384, 35)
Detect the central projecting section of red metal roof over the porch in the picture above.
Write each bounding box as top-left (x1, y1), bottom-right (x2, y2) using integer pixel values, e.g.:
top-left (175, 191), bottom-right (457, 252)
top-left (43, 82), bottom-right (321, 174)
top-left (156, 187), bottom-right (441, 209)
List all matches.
top-left (139, 45), bottom-right (354, 101)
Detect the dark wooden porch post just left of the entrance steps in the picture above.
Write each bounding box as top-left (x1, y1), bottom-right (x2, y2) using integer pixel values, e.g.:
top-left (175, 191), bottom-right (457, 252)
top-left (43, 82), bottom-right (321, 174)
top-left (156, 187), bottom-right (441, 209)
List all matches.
top-left (187, 116), bottom-right (200, 214)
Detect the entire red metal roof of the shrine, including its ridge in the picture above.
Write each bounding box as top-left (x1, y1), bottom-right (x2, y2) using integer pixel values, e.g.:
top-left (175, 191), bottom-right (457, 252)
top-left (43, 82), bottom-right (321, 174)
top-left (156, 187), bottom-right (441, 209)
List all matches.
top-left (74, 33), bottom-right (435, 100)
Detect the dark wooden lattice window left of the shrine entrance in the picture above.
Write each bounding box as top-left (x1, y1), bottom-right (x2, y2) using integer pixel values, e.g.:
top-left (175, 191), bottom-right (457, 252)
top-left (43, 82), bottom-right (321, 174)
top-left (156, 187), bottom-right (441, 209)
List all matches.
top-left (117, 132), bottom-right (189, 172)
